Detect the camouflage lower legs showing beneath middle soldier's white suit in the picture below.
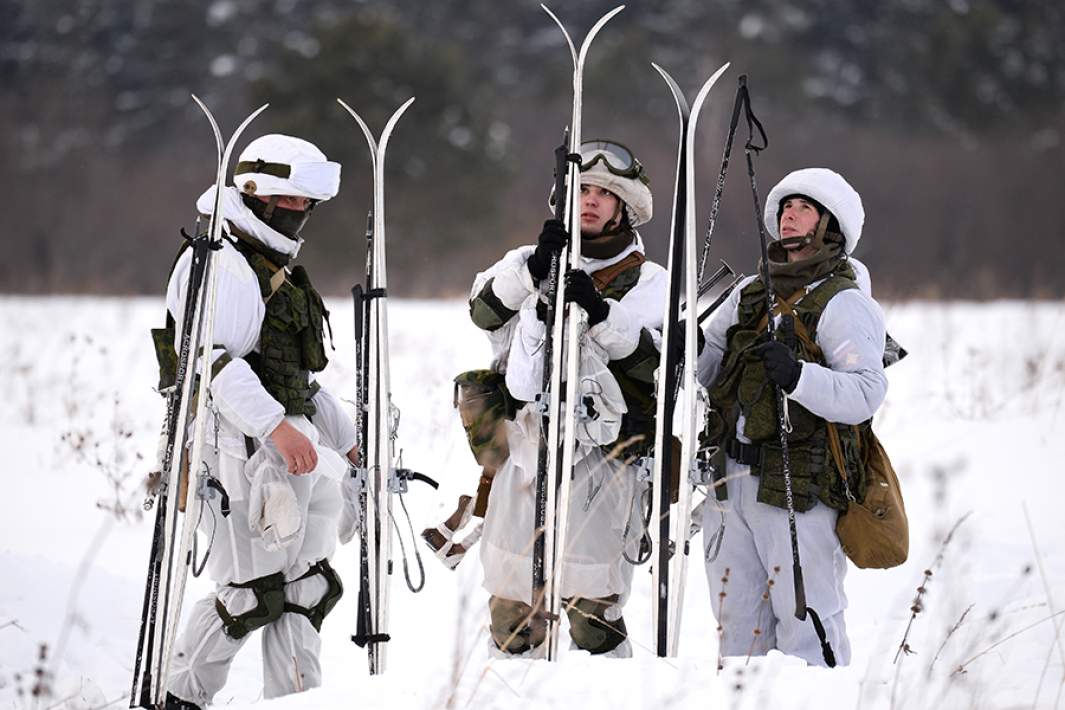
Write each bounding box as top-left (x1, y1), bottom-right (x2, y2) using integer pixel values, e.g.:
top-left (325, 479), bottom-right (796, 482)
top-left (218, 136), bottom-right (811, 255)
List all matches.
top-left (488, 594), bottom-right (628, 654)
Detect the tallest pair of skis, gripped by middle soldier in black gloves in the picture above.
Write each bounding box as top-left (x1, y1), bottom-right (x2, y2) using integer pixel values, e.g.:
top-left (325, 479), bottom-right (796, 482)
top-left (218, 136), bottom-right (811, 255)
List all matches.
top-left (531, 4), bottom-right (625, 660)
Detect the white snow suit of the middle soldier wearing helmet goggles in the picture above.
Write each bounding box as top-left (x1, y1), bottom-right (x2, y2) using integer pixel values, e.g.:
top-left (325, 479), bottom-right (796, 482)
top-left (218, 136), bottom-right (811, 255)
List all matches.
top-left (471, 235), bottom-right (666, 617)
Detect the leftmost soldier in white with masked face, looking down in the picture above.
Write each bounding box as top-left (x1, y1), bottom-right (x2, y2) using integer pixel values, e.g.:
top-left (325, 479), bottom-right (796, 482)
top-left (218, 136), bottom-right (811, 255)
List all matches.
top-left (157, 135), bottom-right (357, 710)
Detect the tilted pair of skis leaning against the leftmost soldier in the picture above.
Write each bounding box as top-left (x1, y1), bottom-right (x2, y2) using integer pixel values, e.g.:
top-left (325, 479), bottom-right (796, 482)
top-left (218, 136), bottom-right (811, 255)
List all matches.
top-left (130, 95), bottom-right (266, 708)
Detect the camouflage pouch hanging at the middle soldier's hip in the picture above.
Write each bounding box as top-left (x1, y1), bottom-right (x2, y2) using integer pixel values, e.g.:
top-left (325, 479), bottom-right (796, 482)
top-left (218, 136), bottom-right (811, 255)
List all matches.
top-left (455, 369), bottom-right (521, 517)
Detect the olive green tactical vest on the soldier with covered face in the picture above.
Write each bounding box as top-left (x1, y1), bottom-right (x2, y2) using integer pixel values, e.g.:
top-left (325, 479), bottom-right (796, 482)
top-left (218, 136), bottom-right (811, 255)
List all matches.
top-left (151, 233), bottom-right (329, 416)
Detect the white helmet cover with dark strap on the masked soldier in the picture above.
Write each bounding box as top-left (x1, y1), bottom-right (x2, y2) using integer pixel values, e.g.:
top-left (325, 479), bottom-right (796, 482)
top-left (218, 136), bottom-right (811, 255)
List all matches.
top-left (233, 133), bottom-right (340, 200)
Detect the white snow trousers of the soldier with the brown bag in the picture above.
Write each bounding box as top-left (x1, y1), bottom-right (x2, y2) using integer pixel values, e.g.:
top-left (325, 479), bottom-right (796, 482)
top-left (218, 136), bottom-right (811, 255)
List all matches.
top-left (703, 459), bottom-right (851, 665)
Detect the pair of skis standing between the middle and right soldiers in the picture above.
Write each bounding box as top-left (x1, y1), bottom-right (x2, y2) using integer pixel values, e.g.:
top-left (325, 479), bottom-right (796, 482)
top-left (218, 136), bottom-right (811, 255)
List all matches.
top-left (651, 63), bottom-right (728, 657)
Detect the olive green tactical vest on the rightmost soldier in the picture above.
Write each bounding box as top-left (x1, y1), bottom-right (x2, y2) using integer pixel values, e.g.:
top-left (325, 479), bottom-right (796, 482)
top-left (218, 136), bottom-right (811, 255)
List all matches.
top-left (706, 275), bottom-right (869, 511)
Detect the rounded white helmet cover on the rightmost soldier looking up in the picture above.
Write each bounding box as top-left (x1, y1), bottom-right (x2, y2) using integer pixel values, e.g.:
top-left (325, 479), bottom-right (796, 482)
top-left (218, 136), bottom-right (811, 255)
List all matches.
top-left (765, 167), bottom-right (865, 253)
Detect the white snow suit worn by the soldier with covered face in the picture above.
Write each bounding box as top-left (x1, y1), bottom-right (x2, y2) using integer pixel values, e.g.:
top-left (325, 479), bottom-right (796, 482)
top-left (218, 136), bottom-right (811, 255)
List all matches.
top-left (166, 187), bottom-right (356, 707)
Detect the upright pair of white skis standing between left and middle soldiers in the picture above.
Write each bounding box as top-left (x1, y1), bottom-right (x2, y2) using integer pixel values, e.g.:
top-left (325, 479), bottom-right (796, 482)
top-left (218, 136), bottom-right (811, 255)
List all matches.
top-left (337, 97), bottom-right (437, 675)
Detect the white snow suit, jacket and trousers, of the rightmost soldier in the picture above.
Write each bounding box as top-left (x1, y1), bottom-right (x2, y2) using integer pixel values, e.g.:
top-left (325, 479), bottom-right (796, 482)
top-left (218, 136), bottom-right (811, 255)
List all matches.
top-left (699, 259), bottom-right (887, 665)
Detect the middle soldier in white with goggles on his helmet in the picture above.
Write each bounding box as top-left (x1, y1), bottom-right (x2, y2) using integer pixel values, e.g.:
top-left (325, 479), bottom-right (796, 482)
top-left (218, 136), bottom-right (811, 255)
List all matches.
top-left (440, 141), bottom-right (665, 657)
